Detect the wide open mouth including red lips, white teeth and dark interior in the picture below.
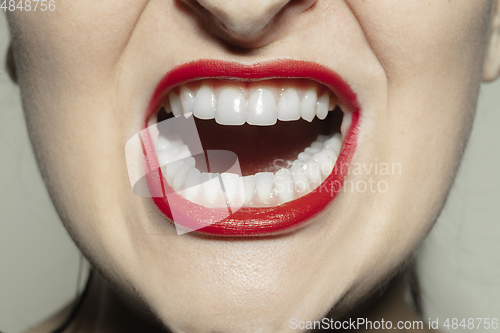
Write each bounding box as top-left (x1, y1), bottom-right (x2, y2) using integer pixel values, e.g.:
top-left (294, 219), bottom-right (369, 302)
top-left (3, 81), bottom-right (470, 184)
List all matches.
top-left (143, 60), bottom-right (359, 236)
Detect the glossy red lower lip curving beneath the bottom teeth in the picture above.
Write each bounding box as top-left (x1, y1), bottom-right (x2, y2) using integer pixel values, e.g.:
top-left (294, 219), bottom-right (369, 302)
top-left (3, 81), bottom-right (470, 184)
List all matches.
top-left (143, 112), bottom-right (359, 237)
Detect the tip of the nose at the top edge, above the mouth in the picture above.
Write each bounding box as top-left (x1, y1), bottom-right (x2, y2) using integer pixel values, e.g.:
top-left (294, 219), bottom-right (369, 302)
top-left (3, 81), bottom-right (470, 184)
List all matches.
top-left (183, 0), bottom-right (316, 47)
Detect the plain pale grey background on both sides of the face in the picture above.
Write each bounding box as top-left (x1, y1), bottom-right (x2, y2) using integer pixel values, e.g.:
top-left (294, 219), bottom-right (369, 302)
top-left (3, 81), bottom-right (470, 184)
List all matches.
top-left (0, 14), bottom-right (500, 333)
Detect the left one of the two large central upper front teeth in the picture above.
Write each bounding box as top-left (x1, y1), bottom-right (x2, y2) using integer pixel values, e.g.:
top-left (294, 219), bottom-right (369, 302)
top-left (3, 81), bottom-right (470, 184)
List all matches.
top-left (215, 88), bottom-right (247, 125)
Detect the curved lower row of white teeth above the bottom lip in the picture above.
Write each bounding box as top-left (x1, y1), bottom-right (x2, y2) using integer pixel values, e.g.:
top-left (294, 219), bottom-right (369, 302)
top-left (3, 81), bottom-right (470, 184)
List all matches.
top-left (157, 133), bottom-right (342, 209)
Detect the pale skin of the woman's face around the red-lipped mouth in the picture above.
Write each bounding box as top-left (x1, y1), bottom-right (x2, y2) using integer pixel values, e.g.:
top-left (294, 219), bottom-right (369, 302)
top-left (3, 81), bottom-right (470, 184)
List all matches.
top-left (5, 0), bottom-right (498, 332)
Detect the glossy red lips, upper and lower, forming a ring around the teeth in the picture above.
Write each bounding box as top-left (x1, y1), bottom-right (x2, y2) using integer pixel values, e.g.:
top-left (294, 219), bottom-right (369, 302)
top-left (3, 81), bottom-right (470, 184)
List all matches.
top-left (143, 59), bottom-right (360, 237)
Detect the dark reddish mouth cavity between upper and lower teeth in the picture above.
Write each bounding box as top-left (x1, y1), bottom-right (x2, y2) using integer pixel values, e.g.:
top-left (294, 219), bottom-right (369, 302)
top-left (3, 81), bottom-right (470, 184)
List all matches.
top-left (158, 107), bottom-right (343, 176)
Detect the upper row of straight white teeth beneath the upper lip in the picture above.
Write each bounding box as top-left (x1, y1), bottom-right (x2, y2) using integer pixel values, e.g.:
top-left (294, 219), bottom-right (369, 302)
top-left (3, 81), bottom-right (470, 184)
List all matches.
top-left (164, 80), bottom-right (337, 126)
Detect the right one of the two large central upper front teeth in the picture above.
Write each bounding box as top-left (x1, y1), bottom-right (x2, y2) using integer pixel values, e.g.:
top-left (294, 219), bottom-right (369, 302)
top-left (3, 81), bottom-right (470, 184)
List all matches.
top-left (247, 88), bottom-right (278, 126)
